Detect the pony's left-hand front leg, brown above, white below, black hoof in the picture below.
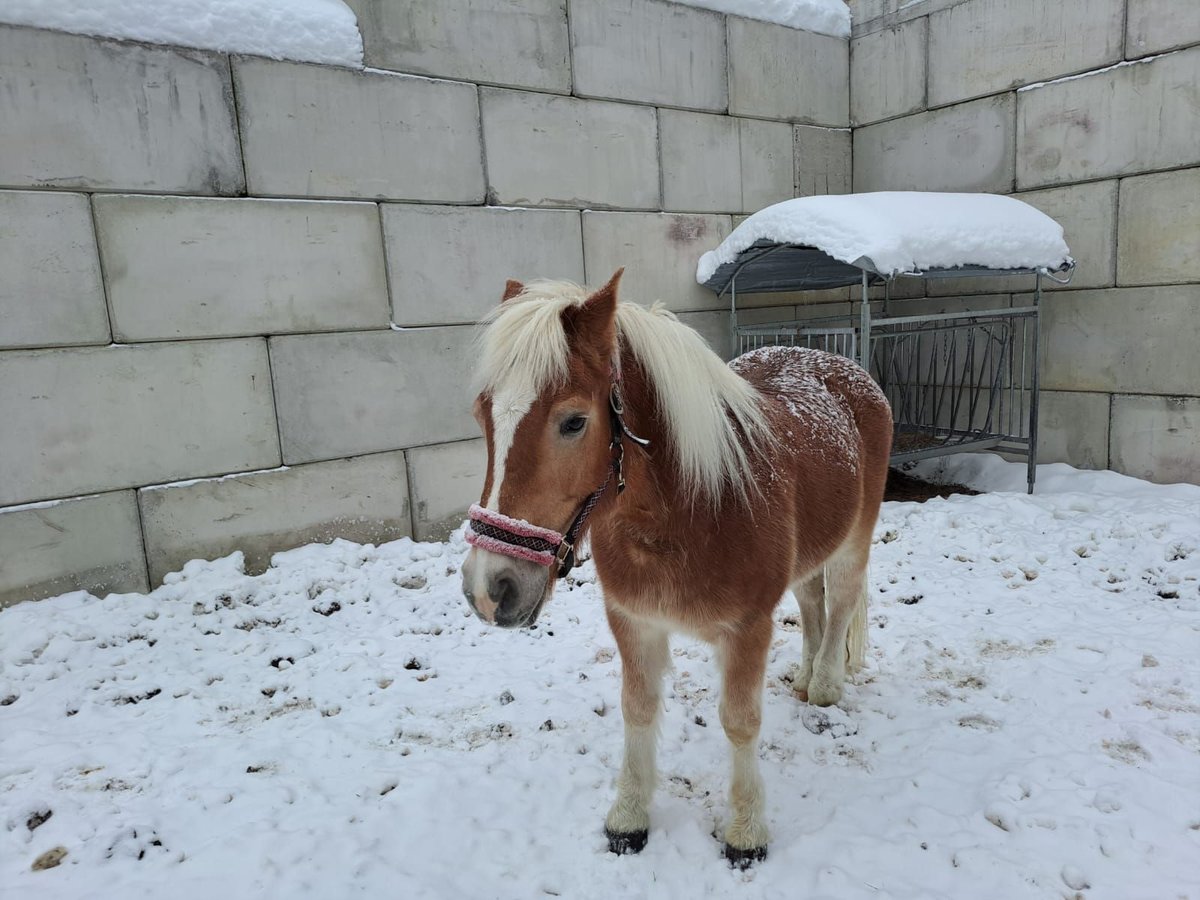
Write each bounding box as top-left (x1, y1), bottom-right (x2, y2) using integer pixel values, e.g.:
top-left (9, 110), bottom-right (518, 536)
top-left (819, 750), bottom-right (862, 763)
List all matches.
top-left (605, 607), bottom-right (671, 854)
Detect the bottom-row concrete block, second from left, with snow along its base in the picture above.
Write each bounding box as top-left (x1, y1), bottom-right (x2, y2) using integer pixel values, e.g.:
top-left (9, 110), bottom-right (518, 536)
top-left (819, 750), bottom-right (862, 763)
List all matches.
top-left (138, 451), bottom-right (412, 584)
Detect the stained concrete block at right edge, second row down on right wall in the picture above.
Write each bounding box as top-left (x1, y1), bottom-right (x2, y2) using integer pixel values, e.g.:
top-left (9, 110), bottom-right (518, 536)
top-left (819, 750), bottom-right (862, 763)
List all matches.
top-left (1016, 47), bottom-right (1200, 190)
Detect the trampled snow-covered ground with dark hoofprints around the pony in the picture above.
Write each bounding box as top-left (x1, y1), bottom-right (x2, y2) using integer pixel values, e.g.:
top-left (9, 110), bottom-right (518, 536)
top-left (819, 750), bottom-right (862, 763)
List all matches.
top-left (0, 457), bottom-right (1200, 900)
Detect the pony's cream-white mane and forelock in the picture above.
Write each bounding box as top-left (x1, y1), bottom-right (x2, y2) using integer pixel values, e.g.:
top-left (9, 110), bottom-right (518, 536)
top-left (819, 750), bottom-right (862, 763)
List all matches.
top-left (478, 281), bottom-right (773, 508)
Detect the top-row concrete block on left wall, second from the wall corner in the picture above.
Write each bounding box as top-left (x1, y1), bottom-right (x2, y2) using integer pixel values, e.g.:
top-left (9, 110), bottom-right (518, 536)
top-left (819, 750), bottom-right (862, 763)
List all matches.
top-left (571, 0), bottom-right (730, 112)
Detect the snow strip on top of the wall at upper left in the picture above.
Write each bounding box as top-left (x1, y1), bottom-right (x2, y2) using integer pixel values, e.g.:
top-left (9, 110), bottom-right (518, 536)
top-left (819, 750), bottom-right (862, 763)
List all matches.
top-left (0, 0), bottom-right (362, 67)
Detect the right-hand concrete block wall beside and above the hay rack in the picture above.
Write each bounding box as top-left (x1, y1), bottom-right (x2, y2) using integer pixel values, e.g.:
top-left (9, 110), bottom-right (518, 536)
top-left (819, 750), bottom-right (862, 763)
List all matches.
top-left (850, 0), bottom-right (1200, 482)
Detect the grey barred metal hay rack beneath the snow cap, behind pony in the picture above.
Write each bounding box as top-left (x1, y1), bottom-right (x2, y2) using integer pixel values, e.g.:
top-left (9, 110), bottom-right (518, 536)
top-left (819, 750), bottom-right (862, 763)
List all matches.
top-left (706, 240), bottom-right (1074, 493)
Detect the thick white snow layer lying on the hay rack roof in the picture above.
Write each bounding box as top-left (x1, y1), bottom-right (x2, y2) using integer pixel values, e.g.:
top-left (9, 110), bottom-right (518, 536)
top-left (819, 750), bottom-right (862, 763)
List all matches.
top-left (696, 191), bottom-right (1070, 284)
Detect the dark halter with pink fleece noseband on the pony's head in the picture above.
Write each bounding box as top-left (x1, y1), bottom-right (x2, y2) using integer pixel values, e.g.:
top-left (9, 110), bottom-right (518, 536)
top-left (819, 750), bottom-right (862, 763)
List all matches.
top-left (467, 373), bottom-right (650, 578)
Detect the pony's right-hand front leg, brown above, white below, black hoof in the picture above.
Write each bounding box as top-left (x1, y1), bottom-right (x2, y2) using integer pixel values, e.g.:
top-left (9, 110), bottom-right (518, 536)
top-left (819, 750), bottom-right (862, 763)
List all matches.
top-left (720, 616), bottom-right (773, 869)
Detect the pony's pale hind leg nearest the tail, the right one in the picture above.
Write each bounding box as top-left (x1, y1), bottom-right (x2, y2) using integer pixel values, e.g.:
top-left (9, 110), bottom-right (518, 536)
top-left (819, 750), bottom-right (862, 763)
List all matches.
top-left (805, 538), bottom-right (871, 707)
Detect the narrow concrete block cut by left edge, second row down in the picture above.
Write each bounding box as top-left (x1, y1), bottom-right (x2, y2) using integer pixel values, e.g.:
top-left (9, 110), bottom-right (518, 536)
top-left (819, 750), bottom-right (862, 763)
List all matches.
top-left (0, 191), bottom-right (108, 349)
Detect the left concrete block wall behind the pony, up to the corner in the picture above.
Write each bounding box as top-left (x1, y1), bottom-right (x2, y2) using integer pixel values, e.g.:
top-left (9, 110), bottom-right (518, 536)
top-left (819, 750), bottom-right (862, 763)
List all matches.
top-left (0, 0), bottom-right (850, 605)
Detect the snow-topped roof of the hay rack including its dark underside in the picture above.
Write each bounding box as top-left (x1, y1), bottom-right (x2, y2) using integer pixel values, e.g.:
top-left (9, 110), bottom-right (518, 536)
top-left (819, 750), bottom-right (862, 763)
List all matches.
top-left (696, 191), bottom-right (1074, 292)
